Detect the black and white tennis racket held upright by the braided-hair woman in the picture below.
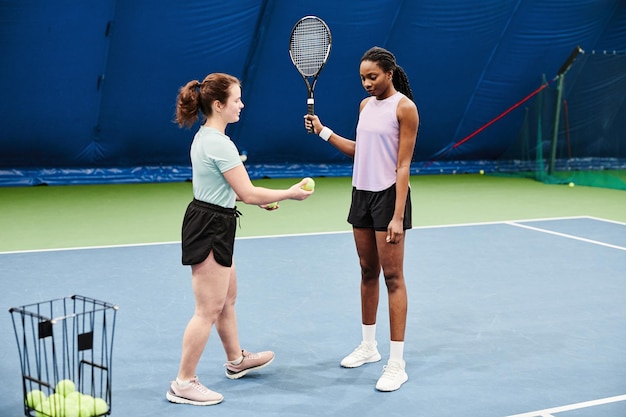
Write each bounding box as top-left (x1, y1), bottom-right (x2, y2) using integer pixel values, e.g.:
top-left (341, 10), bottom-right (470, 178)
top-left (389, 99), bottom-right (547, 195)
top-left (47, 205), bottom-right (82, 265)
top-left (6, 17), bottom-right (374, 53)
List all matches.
top-left (289, 16), bottom-right (332, 133)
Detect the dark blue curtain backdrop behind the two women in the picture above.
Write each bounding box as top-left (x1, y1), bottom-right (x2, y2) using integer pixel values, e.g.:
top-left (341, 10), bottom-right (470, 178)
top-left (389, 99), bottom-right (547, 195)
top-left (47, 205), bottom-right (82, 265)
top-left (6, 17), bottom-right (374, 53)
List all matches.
top-left (0, 0), bottom-right (626, 185)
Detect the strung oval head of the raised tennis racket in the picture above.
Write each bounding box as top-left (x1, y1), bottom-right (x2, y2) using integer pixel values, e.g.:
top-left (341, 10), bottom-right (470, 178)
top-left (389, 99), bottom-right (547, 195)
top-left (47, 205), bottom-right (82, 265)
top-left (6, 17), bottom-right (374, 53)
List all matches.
top-left (289, 19), bottom-right (330, 77)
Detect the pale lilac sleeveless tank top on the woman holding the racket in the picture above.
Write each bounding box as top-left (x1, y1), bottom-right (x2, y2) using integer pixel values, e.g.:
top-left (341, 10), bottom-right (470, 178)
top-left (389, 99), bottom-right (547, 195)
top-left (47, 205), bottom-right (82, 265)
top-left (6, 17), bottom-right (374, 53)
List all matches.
top-left (352, 92), bottom-right (405, 191)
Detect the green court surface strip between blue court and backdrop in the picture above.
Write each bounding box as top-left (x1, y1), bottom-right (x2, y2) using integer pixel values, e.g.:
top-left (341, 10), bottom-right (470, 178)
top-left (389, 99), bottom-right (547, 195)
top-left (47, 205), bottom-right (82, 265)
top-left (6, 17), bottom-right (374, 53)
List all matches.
top-left (0, 174), bottom-right (626, 252)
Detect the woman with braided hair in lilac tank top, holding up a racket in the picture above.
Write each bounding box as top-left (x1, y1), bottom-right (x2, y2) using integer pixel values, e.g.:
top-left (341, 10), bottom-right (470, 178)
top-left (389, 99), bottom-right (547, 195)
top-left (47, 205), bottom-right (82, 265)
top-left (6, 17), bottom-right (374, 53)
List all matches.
top-left (304, 47), bottom-right (419, 391)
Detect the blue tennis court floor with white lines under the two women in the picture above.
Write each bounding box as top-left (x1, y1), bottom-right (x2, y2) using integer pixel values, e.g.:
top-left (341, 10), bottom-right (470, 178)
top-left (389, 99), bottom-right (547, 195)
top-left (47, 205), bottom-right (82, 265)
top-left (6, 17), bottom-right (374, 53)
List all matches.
top-left (0, 217), bottom-right (626, 417)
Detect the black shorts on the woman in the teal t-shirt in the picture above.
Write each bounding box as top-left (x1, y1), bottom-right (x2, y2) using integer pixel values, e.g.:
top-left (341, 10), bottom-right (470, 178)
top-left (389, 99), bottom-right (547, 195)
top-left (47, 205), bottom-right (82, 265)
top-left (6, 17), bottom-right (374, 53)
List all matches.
top-left (181, 198), bottom-right (239, 267)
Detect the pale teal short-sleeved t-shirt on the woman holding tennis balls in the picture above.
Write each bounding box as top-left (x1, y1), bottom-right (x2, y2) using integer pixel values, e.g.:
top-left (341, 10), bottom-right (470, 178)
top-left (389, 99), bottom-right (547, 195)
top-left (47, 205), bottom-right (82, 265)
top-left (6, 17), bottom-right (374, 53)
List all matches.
top-left (190, 126), bottom-right (242, 208)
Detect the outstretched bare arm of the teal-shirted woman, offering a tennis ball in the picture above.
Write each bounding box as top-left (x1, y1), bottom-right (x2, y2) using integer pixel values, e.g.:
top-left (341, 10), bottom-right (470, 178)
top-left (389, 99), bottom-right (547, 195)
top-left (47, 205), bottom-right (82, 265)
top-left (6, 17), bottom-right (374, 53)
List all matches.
top-left (224, 165), bottom-right (313, 205)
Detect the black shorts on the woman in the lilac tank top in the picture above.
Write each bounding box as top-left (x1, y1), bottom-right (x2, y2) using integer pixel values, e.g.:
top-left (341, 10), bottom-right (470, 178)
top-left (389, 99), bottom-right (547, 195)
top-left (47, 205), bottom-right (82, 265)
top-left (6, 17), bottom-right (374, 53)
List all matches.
top-left (348, 184), bottom-right (413, 232)
